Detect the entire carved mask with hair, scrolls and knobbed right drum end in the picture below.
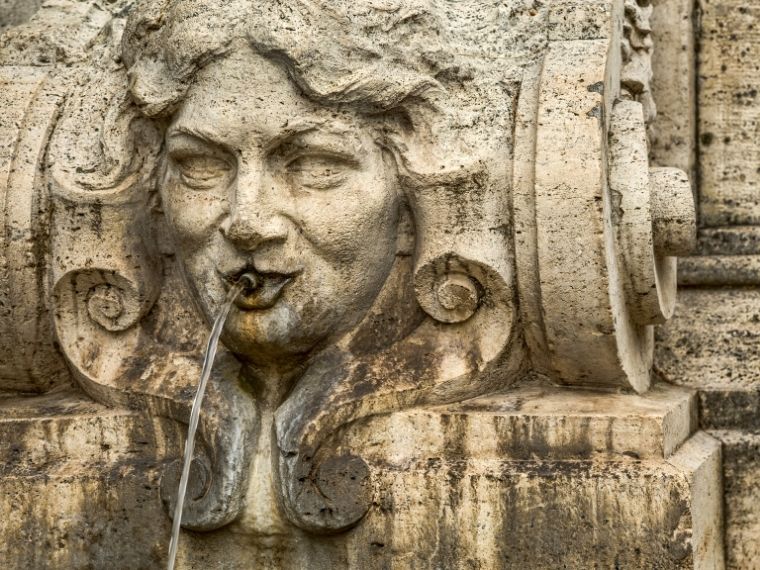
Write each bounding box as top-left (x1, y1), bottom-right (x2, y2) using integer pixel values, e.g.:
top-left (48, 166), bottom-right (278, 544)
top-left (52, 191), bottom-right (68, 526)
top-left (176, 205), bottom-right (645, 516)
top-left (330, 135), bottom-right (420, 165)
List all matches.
top-left (14, 0), bottom-right (694, 532)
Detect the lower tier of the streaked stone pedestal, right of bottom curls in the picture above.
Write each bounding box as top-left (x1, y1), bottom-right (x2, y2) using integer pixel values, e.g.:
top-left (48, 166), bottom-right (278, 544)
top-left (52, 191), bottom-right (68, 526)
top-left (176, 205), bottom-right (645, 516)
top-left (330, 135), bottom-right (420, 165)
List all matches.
top-left (340, 432), bottom-right (723, 570)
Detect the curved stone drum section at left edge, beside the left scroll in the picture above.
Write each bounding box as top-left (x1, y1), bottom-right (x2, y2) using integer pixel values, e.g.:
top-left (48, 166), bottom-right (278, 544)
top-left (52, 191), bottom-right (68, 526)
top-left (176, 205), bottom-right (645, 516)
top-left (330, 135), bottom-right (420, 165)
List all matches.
top-left (0, 65), bottom-right (68, 392)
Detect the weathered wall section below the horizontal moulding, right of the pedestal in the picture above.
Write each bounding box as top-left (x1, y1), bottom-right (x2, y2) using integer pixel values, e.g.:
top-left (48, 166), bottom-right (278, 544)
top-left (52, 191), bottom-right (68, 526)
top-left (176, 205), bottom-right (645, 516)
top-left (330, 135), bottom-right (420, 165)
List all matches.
top-left (655, 288), bottom-right (760, 569)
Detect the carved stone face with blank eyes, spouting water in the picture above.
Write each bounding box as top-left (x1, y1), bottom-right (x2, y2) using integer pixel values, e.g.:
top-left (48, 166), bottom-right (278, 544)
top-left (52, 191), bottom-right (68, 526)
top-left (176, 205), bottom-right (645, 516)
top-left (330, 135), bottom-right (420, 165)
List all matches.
top-left (160, 47), bottom-right (400, 365)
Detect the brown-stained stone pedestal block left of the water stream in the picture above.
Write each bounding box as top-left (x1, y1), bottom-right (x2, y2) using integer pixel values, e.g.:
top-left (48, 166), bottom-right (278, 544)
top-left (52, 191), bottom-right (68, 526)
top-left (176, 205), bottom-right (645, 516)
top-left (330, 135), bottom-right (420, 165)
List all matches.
top-left (0, 390), bottom-right (183, 570)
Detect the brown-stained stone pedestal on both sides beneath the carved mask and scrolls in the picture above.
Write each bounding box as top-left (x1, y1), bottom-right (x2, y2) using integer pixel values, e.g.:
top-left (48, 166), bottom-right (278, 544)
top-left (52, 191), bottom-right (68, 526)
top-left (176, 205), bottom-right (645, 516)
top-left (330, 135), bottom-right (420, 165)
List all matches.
top-left (0, 385), bottom-right (724, 570)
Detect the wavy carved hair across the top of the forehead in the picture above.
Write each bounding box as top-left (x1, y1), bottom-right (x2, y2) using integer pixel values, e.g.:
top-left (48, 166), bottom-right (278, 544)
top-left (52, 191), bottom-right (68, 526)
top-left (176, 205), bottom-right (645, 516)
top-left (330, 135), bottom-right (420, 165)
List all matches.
top-left (122, 0), bottom-right (440, 117)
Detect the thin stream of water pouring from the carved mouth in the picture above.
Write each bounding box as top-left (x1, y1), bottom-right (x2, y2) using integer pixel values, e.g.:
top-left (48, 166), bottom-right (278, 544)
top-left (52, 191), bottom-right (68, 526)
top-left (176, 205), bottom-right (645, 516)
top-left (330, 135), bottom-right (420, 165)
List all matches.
top-left (167, 274), bottom-right (256, 570)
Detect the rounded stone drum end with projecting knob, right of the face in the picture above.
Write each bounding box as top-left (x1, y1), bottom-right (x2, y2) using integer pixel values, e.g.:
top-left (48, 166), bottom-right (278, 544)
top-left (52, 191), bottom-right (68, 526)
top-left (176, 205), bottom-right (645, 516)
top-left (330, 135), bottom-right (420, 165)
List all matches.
top-left (514, 0), bottom-right (695, 392)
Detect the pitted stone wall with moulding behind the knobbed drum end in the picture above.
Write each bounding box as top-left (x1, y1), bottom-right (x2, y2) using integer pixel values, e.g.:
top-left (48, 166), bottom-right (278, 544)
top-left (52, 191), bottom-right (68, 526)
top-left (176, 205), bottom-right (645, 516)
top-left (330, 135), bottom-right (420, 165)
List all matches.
top-left (654, 0), bottom-right (760, 568)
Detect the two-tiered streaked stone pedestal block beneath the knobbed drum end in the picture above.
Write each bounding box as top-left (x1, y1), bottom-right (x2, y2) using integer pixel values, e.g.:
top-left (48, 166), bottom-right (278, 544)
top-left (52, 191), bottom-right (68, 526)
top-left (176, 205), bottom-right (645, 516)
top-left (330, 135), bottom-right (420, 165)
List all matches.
top-left (338, 385), bottom-right (723, 569)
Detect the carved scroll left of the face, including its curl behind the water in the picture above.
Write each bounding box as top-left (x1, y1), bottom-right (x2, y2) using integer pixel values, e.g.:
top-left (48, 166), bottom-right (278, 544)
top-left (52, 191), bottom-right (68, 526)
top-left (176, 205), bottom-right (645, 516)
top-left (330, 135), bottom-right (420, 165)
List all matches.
top-left (43, 24), bottom-right (257, 530)
